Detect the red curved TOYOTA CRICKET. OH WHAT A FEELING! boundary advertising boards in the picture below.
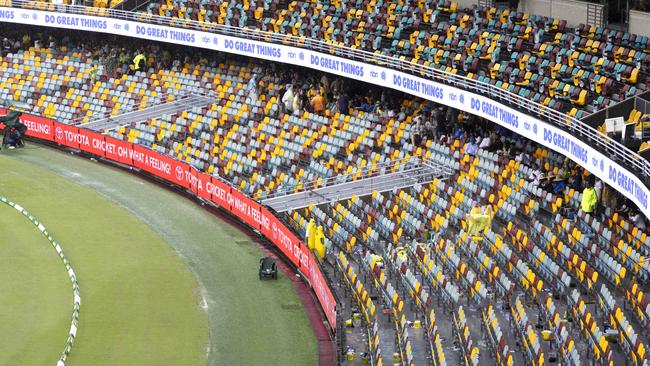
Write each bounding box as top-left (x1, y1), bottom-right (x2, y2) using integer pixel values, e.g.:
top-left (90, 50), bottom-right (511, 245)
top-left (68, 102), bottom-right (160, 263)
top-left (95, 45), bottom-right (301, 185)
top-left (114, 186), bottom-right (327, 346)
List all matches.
top-left (0, 109), bottom-right (336, 331)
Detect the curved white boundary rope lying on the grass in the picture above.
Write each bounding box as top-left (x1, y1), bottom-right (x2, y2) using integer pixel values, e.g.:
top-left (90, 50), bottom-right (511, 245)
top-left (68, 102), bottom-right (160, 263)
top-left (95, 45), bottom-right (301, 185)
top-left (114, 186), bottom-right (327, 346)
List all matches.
top-left (0, 196), bottom-right (81, 366)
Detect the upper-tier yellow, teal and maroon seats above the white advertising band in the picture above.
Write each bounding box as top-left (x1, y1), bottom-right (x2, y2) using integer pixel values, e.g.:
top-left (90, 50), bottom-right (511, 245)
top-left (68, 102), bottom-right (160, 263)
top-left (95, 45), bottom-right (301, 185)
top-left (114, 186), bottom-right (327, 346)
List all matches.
top-left (139, 0), bottom-right (650, 118)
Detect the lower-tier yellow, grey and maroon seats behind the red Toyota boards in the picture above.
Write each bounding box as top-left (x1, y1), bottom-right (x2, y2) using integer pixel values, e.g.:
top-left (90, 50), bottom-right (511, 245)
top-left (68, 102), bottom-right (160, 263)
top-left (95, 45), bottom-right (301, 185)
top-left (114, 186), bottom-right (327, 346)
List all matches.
top-left (0, 30), bottom-right (650, 365)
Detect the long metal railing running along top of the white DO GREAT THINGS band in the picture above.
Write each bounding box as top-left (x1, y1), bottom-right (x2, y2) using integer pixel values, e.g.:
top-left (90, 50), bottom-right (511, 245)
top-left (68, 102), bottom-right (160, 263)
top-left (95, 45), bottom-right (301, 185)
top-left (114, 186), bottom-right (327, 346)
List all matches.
top-left (7, 0), bottom-right (650, 184)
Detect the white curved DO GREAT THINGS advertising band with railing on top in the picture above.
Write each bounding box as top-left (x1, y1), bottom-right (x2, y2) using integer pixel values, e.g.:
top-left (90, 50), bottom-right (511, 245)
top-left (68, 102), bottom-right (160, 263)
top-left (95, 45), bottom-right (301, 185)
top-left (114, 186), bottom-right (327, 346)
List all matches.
top-left (0, 4), bottom-right (650, 217)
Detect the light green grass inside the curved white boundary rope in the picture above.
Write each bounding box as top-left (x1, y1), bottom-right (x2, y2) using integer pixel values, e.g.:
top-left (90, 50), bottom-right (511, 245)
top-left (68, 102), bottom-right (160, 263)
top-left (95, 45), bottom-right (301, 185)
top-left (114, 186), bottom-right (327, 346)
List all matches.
top-left (0, 196), bottom-right (72, 365)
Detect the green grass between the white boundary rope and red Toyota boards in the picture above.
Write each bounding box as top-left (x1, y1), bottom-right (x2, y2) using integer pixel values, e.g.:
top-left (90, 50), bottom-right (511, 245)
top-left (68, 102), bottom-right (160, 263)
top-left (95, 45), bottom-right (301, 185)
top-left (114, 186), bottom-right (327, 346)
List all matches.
top-left (0, 144), bottom-right (318, 366)
